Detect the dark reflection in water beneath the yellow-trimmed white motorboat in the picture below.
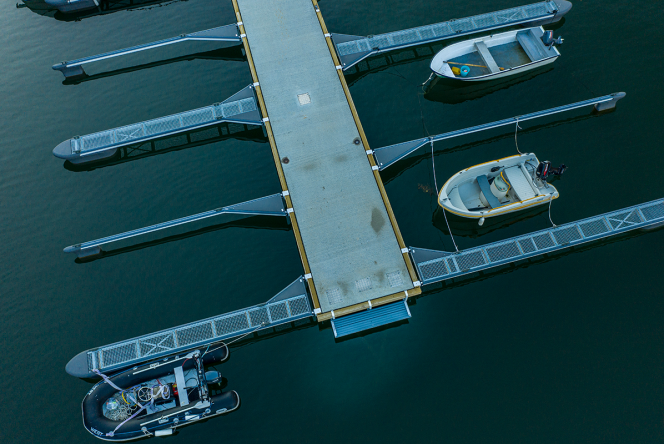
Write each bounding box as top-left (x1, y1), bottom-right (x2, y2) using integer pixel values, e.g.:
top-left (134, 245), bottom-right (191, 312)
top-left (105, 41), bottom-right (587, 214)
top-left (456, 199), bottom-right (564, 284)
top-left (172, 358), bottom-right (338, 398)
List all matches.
top-left (432, 205), bottom-right (549, 239)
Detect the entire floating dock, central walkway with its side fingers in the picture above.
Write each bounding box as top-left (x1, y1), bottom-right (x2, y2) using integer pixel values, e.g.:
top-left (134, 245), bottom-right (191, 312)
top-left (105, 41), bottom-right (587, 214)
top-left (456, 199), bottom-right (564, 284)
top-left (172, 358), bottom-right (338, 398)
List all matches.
top-left (54, 0), bottom-right (664, 377)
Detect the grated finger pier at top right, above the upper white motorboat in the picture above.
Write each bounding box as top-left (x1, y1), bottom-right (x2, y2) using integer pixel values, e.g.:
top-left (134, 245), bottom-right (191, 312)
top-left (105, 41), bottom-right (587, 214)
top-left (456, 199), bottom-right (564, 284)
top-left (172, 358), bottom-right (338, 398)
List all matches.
top-left (332, 1), bottom-right (559, 70)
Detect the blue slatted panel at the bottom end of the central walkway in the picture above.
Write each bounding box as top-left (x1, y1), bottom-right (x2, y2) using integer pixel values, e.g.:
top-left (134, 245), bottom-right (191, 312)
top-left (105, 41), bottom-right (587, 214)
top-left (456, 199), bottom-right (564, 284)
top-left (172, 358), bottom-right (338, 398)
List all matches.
top-left (332, 299), bottom-right (410, 338)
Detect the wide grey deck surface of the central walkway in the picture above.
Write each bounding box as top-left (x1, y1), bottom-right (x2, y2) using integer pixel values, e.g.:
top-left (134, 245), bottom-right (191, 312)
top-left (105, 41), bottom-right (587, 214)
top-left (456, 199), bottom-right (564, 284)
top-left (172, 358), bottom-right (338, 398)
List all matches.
top-left (238, 0), bottom-right (413, 312)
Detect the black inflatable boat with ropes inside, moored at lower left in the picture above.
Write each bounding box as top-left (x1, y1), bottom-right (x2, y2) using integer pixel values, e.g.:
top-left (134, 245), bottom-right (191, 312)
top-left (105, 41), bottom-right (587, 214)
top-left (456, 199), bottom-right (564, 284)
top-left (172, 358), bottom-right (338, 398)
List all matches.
top-left (82, 344), bottom-right (240, 441)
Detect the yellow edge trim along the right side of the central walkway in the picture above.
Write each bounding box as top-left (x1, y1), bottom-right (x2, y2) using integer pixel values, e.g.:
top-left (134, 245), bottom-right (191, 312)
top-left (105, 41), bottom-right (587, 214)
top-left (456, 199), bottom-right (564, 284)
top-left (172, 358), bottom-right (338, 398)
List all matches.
top-left (312, 0), bottom-right (419, 284)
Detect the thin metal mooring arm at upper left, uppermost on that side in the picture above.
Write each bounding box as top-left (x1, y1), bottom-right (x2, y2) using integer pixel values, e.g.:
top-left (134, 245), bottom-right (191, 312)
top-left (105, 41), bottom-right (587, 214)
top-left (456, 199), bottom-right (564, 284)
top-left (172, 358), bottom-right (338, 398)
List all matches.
top-left (53, 24), bottom-right (242, 78)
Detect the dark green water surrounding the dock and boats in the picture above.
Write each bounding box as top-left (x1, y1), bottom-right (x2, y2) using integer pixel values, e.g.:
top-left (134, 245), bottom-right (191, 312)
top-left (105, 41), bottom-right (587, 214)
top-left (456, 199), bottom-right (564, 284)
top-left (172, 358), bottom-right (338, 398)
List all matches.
top-left (0, 0), bottom-right (664, 443)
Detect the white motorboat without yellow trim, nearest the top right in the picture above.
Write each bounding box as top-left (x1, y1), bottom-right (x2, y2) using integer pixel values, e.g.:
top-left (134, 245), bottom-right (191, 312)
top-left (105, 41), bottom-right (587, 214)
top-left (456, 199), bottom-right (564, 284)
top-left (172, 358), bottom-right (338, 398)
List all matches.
top-left (431, 26), bottom-right (562, 82)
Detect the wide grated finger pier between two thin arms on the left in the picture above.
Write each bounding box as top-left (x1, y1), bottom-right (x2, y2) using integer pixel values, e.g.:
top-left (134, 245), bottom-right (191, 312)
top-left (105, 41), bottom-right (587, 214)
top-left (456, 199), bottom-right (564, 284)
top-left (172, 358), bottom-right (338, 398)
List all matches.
top-left (53, 85), bottom-right (263, 159)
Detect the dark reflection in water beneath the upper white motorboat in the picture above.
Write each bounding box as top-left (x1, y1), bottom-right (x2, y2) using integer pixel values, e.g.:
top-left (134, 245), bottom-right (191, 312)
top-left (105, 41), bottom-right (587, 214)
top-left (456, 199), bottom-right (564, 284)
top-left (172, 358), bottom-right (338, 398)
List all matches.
top-left (424, 66), bottom-right (553, 105)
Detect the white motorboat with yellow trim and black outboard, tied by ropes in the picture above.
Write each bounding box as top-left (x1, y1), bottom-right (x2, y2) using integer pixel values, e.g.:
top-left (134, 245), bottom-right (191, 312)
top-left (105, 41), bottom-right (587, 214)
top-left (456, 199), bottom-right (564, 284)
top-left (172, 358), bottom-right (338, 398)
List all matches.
top-left (438, 153), bottom-right (567, 225)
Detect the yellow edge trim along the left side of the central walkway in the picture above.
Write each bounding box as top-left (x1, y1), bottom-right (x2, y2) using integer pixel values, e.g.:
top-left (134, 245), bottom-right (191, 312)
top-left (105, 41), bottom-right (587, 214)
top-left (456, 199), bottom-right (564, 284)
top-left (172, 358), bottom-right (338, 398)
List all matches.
top-left (232, 0), bottom-right (320, 310)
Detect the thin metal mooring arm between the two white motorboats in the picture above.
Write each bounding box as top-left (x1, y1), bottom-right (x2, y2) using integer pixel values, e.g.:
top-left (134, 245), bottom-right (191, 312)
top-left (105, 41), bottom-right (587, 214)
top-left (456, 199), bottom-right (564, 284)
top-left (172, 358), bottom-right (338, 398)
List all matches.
top-left (373, 92), bottom-right (626, 171)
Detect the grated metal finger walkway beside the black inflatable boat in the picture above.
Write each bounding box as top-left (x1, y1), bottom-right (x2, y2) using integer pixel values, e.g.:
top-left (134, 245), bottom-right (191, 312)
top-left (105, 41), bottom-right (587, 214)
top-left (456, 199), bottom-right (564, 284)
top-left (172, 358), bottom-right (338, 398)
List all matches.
top-left (81, 277), bottom-right (313, 372)
